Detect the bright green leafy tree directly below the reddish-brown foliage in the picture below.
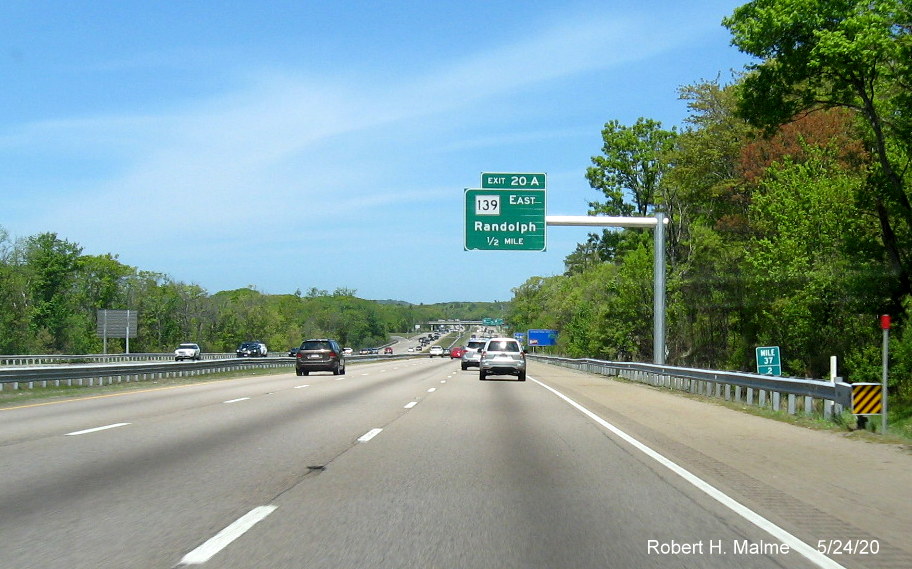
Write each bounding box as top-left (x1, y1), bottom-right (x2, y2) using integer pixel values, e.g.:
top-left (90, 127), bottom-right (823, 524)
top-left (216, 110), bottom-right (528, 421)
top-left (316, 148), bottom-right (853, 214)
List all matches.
top-left (745, 147), bottom-right (885, 377)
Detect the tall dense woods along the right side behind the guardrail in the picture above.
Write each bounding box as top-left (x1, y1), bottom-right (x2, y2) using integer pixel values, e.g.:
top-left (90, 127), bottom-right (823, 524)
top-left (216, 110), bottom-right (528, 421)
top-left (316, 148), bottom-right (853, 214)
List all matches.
top-left (509, 0), bottom-right (912, 400)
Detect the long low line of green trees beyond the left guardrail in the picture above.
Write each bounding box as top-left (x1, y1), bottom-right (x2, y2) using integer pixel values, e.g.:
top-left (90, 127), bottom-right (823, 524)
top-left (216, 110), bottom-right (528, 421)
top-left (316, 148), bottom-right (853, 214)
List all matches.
top-left (0, 227), bottom-right (506, 354)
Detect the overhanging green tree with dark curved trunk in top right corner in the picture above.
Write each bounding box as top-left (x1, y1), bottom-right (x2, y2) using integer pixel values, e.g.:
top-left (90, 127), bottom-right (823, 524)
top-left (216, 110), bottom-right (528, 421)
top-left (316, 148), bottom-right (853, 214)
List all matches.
top-left (723, 0), bottom-right (912, 305)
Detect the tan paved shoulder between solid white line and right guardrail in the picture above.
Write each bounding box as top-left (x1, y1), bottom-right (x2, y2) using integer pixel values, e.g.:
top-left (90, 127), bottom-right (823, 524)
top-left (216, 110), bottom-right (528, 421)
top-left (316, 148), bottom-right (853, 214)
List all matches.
top-left (529, 362), bottom-right (912, 567)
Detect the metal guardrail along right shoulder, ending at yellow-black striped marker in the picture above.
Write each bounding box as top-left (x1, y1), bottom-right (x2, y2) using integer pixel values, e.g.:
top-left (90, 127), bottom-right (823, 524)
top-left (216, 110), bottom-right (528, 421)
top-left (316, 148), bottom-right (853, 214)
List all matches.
top-left (528, 354), bottom-right (852, 417)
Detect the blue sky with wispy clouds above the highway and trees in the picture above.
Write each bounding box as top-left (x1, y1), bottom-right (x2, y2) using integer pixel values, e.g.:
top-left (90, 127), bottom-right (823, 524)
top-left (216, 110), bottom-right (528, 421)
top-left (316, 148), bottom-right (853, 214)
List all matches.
top-left (0, 0), bottom-right (748, 303)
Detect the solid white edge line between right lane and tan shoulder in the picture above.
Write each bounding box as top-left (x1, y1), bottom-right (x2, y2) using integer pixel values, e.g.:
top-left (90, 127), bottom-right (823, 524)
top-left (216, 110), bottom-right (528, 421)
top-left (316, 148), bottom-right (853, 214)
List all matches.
top-left (529, 377), bottom-right (845, 569)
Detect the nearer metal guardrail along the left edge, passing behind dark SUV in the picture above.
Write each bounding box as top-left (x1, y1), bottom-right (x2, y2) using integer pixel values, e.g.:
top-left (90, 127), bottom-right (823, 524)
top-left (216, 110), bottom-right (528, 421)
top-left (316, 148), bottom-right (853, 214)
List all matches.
top-left (0, 354), bottom-right (417, 391)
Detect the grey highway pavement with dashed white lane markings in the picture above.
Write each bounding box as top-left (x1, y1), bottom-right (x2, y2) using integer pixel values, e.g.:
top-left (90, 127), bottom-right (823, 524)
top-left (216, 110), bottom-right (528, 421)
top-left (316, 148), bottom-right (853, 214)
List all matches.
top-left (0, 357), bottom-right (908, 569)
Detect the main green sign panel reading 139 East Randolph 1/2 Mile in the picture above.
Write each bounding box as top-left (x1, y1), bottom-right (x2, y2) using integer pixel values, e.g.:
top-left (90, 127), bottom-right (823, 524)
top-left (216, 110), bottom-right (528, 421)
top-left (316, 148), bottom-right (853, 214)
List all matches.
top-left (465, 188), bottom-right (547, 251)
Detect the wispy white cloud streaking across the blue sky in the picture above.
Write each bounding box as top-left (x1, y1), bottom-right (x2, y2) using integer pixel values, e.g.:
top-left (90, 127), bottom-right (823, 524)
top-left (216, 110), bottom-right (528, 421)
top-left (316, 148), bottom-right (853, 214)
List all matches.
top-left (0, 3), bottom-right (732, 298)
